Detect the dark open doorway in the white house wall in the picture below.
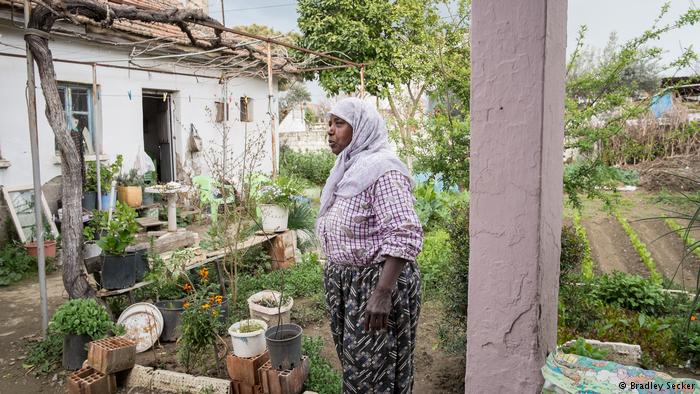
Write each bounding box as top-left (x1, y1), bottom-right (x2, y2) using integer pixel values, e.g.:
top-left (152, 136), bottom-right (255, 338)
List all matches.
top-left (143, 90), bottom-right (176, 182)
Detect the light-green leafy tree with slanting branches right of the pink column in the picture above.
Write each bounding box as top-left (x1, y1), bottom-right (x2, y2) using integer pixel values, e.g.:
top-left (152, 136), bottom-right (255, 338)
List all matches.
top-left (564, 3), bottom-right (700, 207)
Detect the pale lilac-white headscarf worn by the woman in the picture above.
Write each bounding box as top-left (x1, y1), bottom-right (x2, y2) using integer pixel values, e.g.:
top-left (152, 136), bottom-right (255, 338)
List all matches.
top-left (318, 97), bottom-right (411, 218)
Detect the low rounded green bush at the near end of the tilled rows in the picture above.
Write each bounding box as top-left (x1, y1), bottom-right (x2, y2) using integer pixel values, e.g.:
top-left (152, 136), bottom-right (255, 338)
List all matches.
top-left (593, 272), bottom-right (668, 315)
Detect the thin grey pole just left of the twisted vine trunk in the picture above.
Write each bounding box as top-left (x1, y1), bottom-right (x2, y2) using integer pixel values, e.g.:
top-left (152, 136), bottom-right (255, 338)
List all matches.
top-left (23, 0), bottom-right (49, 337)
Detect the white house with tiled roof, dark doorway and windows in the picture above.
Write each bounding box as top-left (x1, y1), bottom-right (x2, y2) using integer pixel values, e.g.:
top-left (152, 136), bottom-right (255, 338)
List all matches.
top-left (0, 0), bottom-right (289, 240)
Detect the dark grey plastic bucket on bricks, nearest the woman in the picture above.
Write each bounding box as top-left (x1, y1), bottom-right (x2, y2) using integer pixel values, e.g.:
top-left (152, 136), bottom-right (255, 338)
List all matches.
top-left (265, 323), bottom-right (302, 371)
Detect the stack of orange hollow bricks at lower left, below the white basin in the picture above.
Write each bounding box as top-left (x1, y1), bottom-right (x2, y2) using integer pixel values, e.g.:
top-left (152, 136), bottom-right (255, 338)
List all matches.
top-left (67, 337), bottom-right (136, 394)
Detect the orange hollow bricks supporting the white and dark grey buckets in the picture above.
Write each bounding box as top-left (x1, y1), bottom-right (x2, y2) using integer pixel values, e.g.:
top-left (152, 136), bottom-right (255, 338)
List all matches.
top-left (226, 352), bottom-right (309, 394)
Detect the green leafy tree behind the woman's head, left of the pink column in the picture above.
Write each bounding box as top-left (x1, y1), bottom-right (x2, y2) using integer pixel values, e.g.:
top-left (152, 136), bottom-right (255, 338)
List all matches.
top-left (298, 0), bottom-right (469, 171)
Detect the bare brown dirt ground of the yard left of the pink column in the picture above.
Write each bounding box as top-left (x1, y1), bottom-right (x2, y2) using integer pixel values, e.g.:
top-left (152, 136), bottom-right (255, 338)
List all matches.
top-left (0, 271), bottom-right (464, 394)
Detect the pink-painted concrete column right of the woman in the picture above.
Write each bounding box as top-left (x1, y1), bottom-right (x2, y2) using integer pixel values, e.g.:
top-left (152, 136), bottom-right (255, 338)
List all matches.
top-left (465, 0), bottom-right (567, 394)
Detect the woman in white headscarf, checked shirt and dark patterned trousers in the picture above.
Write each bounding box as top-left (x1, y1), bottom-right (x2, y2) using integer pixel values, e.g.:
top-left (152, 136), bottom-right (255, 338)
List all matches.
top-left (316, 98), bottom-right (423, 393)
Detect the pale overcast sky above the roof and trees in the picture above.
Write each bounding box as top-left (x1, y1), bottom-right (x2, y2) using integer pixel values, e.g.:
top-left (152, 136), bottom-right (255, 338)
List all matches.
top-left (209, 0), bottom-right (700, 102)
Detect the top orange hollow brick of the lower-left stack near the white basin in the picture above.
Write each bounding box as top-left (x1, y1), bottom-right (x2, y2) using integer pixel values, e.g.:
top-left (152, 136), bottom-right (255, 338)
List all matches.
top-left (87, 337), bottom-right (136, 374)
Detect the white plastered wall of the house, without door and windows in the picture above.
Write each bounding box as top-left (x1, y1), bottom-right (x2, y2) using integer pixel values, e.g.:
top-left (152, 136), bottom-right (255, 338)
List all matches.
top-left (0, 21), bottom-right (277, 240)
